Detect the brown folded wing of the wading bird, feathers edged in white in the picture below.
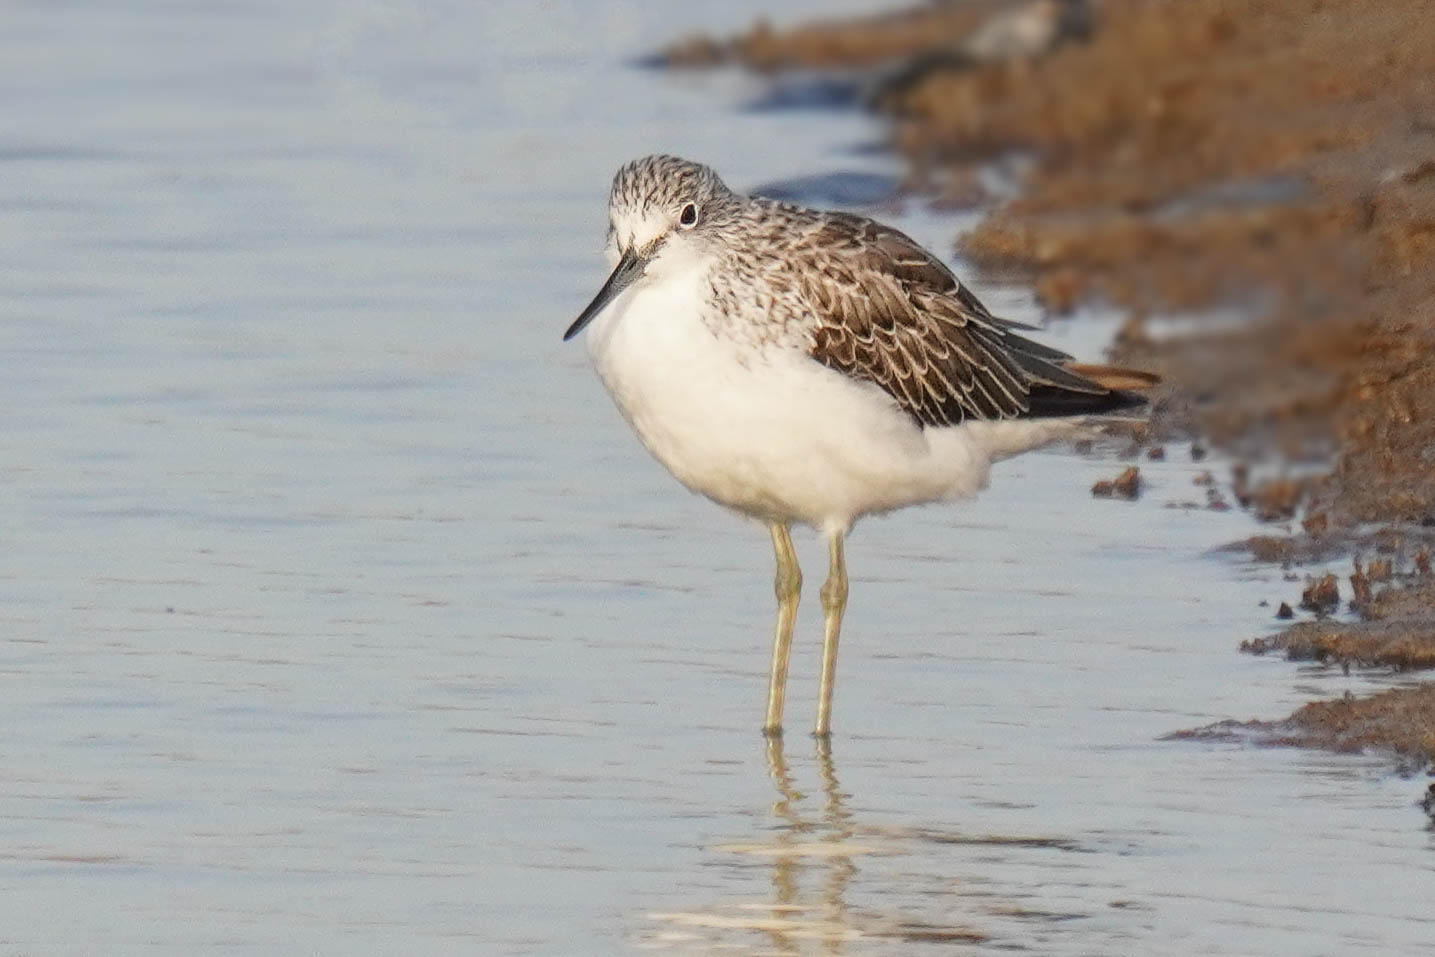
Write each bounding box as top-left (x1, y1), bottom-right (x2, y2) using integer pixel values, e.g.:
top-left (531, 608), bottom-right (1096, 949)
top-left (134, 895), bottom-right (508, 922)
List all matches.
top-left (791, 214), bottom-right (1061, 426)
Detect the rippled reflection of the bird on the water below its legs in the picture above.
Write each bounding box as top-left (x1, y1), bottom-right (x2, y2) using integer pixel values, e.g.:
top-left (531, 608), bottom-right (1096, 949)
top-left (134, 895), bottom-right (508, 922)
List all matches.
top-left (640, 737), bottom-right (1089, 956)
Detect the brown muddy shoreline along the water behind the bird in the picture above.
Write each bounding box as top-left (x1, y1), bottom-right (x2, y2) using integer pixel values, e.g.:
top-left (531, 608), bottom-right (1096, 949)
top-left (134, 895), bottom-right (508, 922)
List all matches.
top-left (656, 0), bottom-right (1435, 766)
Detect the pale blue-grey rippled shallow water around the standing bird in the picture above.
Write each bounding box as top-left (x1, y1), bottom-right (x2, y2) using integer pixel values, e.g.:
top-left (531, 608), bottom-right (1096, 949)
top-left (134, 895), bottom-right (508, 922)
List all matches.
top-left (0, 0), bottom-right (1435, 954)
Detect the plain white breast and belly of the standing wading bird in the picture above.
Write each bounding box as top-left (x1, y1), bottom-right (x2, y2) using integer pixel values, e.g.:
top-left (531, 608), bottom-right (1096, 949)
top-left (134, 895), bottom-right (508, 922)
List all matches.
top-left (588, 269), bottom-right (1029, 529)
